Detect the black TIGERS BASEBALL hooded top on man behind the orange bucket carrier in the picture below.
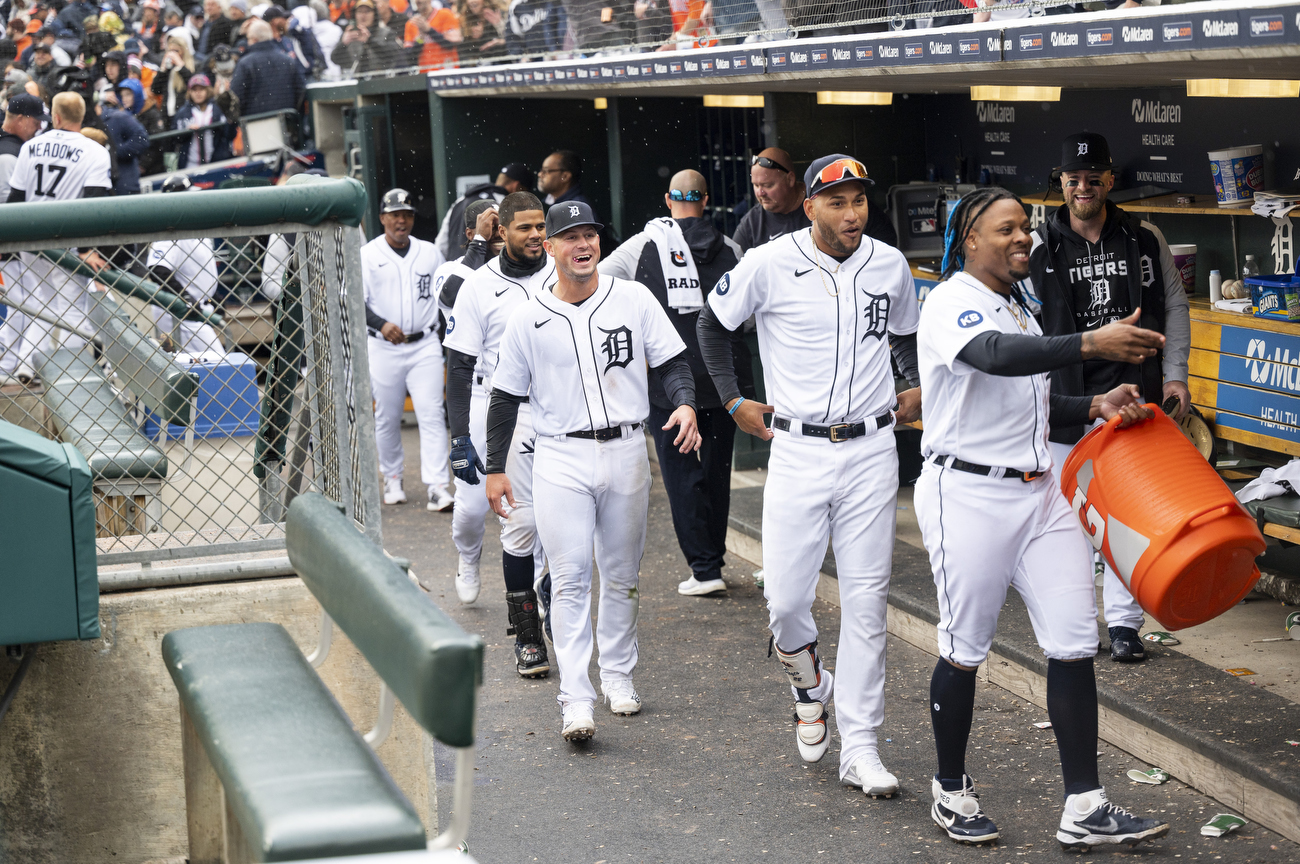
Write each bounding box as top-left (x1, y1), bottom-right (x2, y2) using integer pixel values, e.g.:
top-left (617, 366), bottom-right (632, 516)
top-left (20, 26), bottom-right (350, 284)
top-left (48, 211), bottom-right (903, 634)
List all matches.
top-left (1030, 201), bottom-right (1165, 444)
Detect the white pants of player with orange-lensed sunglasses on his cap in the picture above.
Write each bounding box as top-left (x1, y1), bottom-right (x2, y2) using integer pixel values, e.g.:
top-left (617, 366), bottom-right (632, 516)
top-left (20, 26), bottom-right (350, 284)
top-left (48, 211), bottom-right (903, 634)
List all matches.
top-left (763, 424), bottom-right (898, 778)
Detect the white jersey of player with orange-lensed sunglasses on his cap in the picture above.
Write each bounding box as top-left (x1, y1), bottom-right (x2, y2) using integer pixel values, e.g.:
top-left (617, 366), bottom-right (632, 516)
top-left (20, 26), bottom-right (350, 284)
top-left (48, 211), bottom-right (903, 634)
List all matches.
top-left (709, 229), bottom-right (919, 425)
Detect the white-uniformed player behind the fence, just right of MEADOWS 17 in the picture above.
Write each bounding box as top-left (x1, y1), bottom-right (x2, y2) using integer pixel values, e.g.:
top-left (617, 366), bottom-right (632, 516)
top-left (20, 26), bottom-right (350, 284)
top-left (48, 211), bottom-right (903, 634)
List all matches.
top-left (144, 174), bottom-right (226, 355)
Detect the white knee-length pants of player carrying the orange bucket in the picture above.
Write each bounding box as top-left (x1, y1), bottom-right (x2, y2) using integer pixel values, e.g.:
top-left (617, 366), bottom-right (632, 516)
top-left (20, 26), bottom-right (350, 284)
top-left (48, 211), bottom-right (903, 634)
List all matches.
top-left (914, 461), bottom-right (1097, 667)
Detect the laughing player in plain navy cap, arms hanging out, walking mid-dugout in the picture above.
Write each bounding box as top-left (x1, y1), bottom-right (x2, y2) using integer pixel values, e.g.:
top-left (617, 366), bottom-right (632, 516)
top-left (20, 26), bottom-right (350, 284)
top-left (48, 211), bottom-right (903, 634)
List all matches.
top-left (486, 201), bottom-right (699, 741)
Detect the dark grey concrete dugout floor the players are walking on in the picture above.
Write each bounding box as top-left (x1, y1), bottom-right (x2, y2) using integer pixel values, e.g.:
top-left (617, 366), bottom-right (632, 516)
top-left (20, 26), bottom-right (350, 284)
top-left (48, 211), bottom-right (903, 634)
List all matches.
top-left (384, 429), bottom-right (1300, 864)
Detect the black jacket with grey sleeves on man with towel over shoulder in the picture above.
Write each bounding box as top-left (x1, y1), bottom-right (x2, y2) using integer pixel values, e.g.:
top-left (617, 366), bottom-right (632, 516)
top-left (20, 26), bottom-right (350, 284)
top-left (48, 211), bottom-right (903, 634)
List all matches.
top-left (601, 211), bottom-right (755, 411)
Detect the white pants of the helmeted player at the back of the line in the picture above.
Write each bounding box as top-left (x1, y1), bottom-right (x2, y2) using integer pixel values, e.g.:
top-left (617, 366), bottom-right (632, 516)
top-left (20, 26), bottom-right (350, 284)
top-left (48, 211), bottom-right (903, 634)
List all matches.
top-left (368, 335), bottom-right (451, 487)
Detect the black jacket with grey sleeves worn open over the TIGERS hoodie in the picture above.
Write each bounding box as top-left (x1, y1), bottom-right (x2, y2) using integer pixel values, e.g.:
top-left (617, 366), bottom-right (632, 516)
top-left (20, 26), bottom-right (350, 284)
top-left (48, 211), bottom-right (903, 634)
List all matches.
top-left (1030, 201), bottom-right (1166, 444)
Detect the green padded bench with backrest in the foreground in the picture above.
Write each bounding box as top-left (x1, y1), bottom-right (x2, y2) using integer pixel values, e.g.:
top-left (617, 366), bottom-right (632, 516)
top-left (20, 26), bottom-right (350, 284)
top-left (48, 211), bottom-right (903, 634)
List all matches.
top-left (163, 492), bottom-right (484, 863)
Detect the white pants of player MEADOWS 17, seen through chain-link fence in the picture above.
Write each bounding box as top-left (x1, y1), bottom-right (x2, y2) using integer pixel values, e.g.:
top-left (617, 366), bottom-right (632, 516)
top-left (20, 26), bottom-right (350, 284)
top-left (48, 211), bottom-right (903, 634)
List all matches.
top-left (4, 252), bottom-right (95, 372)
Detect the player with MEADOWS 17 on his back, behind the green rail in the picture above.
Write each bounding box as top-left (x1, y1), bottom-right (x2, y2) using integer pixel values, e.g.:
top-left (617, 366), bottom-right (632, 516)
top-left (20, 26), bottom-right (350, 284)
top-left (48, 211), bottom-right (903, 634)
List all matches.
top-left (9, 92), bottom-right (113, 381)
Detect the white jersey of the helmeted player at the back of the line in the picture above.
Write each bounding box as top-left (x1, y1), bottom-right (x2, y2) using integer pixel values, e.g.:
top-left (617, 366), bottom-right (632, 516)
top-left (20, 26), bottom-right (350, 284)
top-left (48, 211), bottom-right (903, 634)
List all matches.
top-left (361, 234), bottom-right (438, 333)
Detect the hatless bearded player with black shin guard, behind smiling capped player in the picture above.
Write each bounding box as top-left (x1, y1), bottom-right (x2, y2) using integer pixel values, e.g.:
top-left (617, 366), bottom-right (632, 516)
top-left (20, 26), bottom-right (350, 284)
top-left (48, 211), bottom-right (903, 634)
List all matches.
top-left (445, 192), bottom-right (555, 678)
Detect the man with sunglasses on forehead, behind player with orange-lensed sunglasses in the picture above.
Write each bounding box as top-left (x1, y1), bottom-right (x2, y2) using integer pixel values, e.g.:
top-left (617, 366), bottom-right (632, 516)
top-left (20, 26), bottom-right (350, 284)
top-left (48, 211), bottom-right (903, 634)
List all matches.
top-left (732, 147), bottom-right (898, 255)
